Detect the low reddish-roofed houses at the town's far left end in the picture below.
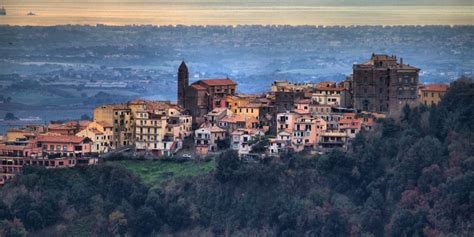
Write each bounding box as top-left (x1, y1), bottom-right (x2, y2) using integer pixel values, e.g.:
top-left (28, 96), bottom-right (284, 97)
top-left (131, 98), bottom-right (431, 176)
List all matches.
top-left (0, 121), bottom-right (98, 184)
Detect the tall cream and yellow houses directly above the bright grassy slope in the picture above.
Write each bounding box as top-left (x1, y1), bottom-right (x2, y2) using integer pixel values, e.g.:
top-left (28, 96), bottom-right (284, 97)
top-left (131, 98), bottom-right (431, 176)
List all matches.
top-left (94, 100), bottom-right (193, 156)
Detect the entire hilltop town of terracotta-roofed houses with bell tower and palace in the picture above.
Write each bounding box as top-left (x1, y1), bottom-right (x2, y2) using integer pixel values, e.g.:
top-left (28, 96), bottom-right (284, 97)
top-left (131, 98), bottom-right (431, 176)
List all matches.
top-left (0, 54), bottom-right (448, 184)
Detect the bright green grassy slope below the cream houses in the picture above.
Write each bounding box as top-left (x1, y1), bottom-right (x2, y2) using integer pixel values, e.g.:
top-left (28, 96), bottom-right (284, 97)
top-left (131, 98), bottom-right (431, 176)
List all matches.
top-left (113, 160), bottom-right (216, 186)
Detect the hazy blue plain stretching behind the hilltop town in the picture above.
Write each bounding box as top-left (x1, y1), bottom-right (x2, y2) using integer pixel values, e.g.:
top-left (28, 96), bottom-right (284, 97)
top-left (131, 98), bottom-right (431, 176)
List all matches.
top-left (0, 25), bottom-right (473, 130)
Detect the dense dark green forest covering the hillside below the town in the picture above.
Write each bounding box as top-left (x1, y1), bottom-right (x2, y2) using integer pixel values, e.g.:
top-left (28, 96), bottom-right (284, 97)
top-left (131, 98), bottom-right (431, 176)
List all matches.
top-left (0, 78), bottom-right (474, 236)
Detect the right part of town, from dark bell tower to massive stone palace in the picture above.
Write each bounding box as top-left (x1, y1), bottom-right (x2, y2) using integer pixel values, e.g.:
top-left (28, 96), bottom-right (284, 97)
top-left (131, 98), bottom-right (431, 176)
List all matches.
top-left (178, 54), bottom-right (448, 156)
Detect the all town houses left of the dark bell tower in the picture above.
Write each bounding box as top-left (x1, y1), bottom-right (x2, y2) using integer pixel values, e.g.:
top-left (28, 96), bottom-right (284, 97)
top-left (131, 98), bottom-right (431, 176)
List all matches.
top-left (0, 100), bottom-right (193, 184)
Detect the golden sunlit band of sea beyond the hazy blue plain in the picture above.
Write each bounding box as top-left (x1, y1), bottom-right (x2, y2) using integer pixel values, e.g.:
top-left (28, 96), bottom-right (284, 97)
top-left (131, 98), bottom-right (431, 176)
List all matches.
top-left (0, 0), bottom-right (474, 25)
